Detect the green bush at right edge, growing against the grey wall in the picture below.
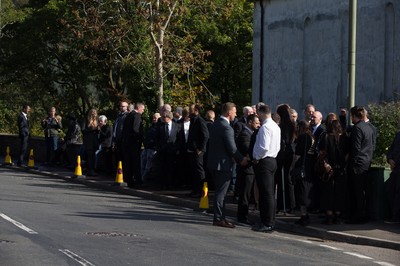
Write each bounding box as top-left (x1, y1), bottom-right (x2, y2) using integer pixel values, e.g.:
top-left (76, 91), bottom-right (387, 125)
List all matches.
top-left (368, 102), bottom-right (400, 166)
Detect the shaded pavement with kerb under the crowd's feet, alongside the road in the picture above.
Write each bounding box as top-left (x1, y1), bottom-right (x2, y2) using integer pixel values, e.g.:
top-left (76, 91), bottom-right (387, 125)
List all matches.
top-left (0, 158), bottom-right (400, 250)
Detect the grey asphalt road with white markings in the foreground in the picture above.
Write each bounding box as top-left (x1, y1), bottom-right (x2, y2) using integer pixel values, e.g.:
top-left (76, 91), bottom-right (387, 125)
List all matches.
top-left (0, 168), bottom-right (400, 266)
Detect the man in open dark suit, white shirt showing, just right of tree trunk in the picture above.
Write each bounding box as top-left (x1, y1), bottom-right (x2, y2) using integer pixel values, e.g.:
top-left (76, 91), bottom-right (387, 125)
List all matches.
top-left (156, 111), bottom-right (181, 188)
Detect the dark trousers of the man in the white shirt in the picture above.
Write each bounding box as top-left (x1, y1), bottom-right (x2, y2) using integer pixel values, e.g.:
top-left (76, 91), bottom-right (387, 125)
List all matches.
top-left (253, 157), bottom-right (277, 226)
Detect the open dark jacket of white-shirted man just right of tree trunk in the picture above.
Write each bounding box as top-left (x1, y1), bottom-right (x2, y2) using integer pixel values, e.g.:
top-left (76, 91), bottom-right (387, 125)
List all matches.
top-left (156, 121), bottom-right (182, 154)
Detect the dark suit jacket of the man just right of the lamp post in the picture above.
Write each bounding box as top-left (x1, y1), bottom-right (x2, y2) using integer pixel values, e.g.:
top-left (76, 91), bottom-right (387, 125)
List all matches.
top-left (350, 120), bottom-right (374, 174)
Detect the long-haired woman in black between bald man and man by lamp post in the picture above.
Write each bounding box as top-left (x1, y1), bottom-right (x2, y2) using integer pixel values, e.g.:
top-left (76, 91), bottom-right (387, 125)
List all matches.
top-left (318, 120), bottom-right (349, 224)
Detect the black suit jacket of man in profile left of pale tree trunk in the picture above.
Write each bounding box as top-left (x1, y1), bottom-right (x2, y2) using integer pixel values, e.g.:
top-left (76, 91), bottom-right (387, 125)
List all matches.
top-left (122, 111), bottom-right (144, 150)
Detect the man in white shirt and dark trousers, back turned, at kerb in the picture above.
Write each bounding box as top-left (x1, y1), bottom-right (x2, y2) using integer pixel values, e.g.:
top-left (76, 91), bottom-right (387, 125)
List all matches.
top-left (252, 105), bottom-right (281, 233)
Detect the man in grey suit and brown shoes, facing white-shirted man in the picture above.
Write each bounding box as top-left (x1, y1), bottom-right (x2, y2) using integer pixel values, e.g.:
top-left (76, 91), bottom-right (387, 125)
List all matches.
top-left (207, 102), bottom-right (247, 228)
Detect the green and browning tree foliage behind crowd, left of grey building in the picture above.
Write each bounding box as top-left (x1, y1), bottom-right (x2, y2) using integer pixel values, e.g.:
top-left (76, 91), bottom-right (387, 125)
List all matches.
top-left (0, 0), bottom-right (253, 135)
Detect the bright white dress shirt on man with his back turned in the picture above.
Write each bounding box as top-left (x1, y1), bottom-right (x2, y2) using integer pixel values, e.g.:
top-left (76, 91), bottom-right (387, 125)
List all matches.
top-left (253, 118), bottom-right (281, 160)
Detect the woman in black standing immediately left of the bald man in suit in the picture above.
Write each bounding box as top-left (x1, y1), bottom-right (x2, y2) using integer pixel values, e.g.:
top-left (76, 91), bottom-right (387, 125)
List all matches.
top-left (294, 120), bottom-right (314, 226)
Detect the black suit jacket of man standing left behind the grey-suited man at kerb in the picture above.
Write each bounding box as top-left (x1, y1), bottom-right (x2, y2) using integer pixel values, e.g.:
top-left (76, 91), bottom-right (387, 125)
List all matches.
top-left (187, 115), bottom-right (209, 152)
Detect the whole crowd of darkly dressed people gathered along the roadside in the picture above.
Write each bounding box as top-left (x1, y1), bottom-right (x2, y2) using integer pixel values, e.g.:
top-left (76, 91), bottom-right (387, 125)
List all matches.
top-left (18, 101), bottom-right (400, 232)
